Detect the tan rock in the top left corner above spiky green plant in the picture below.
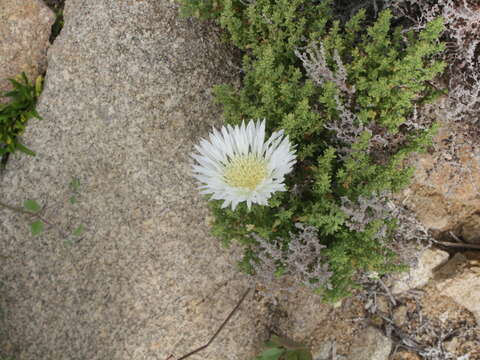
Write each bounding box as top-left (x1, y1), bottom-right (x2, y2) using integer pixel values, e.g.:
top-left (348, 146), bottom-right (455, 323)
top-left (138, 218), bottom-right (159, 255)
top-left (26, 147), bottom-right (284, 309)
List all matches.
top-left (0, 0), bottom-right (55, 92)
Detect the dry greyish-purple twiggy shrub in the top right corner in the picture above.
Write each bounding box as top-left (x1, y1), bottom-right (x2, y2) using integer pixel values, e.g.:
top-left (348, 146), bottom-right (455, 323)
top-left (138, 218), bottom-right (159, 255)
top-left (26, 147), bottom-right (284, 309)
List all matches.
top-left (390, 0), bottom-right (480, 125)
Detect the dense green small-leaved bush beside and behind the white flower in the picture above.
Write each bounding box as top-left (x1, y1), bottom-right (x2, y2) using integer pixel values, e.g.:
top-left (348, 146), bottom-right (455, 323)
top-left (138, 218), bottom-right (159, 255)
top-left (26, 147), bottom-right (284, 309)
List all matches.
top-left (182, 0), bottom-right (445, 301)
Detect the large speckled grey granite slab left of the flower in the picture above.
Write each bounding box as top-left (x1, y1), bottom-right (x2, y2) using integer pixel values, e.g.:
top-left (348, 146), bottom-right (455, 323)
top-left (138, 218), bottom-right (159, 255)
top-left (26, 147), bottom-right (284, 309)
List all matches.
top-left (0, 0), bottom-right (265, 360)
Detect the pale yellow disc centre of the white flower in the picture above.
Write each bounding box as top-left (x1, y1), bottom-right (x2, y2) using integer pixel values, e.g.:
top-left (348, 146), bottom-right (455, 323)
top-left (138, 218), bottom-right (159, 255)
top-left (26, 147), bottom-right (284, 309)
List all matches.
top-left (223, 155), bottom-right (267, 190)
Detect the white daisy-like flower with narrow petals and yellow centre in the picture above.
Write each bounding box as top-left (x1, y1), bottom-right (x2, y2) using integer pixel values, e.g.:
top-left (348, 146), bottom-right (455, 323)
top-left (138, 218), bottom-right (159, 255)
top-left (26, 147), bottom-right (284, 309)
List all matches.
top-left (192, 120), bottom-right (296, 210)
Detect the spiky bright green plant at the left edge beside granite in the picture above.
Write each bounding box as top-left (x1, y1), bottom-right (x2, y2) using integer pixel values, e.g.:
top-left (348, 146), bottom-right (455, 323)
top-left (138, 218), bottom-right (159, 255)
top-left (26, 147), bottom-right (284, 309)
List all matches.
top-left (0, 73), bottom-right (43, 166)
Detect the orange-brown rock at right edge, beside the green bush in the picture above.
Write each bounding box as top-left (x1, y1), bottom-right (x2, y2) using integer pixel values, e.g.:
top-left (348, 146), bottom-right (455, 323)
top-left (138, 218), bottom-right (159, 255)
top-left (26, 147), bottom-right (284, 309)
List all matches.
top-left (403, 123), bottom-right (480, 243)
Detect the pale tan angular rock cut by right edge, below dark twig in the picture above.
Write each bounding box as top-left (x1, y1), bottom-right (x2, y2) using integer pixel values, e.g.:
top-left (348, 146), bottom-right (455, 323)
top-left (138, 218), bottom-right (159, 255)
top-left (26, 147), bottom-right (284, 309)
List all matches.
top-left (435, 253), bottom-right (480, 325)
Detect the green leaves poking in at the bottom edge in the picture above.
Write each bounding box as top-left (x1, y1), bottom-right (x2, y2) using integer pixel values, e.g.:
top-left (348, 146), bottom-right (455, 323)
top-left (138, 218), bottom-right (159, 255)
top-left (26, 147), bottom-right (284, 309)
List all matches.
top-left (255, 335), bottom-right (313, 360)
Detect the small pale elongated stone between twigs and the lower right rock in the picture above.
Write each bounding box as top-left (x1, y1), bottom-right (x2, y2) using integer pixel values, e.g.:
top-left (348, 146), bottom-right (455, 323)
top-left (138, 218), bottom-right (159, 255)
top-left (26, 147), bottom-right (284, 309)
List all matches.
top-left (390, 248), bottom-right (449, 295)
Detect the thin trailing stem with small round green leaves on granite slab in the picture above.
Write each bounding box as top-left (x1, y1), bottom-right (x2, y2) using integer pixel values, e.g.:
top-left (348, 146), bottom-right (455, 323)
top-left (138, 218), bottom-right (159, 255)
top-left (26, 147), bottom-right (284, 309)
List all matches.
top-left (0, 178), bottom-right (85, 245)
